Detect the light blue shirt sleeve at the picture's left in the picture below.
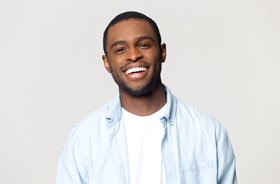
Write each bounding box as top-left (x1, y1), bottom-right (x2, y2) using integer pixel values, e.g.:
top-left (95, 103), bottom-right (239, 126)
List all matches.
top-left (56, 128), bottom-right (87, 184)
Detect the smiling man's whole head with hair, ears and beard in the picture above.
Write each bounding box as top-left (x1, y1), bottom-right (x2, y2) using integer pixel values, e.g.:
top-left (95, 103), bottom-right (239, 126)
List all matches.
top-left (102, 12), bottom-right (166, 97)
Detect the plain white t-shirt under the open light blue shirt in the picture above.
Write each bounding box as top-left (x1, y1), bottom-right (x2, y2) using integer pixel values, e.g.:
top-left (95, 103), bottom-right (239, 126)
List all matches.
top-left (122, 105), bottom-right (166, 184)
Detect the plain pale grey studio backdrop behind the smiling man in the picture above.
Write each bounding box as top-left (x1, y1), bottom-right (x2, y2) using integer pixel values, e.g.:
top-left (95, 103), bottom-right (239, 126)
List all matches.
top-left (0, 0), bottom-right (280, 184)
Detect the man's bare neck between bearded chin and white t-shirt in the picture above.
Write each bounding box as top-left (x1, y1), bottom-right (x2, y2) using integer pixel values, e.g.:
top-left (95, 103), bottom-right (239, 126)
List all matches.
top-left (120, 83), bottom-right (166, 116)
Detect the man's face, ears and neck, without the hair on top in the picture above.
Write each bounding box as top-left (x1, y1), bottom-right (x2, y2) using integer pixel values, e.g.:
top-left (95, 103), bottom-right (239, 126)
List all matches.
top-left (102, 19), bottom-right (166, 116)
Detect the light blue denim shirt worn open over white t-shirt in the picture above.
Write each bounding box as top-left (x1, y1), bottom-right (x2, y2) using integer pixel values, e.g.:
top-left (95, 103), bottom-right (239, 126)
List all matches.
top-left (56, 88), bottom-right (237, 184)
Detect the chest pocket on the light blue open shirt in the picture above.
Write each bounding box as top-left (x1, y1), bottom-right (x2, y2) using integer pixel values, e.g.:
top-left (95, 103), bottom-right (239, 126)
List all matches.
top-left (180, 160), bottom-right (217, 184)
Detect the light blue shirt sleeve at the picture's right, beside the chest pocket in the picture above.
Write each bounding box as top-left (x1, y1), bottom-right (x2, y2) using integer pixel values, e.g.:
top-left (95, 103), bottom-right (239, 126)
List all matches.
top-left (217, 128), bottom-right (237, 184)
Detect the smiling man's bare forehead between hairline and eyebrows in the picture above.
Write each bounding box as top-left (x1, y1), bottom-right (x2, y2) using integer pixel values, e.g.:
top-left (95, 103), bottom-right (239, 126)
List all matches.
top-left (107, 19), bottom-right (157, 44)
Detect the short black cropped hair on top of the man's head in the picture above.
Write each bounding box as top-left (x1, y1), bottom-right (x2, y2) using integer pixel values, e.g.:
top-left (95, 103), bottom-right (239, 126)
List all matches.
top-left (103, 11), bottom-right (161, 55)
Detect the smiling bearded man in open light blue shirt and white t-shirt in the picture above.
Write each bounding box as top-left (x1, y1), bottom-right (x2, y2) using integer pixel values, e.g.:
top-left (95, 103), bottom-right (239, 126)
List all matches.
top-left (57, 12), bottom-right (237, 184)
